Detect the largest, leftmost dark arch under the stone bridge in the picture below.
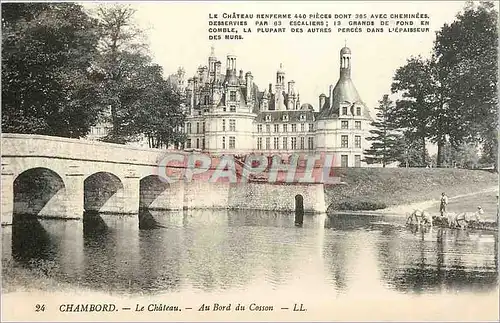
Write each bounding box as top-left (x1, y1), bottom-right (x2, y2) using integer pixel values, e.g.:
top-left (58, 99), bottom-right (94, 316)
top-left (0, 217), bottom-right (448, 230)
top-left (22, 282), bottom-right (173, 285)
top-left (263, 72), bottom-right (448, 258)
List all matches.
top-left (13, 167), bottom-right (66, 216)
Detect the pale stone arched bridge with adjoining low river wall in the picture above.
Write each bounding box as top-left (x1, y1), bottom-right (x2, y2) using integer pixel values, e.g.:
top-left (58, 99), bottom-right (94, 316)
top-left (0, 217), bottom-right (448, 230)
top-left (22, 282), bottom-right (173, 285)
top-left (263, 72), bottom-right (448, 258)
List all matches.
top-left (1, 133), bottom-right (326, 224)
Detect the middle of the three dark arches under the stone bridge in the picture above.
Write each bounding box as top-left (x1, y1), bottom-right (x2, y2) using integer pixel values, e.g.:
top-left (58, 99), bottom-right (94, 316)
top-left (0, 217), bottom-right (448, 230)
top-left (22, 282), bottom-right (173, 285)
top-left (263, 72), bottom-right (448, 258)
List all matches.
top-left (83, 172), bottom-right (124, 213)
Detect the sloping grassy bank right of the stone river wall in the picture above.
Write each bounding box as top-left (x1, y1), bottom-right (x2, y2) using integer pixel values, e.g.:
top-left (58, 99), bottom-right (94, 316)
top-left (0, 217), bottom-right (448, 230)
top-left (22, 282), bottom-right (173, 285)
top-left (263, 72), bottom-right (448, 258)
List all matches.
top-left (325, 168), bottom-right (498, 212)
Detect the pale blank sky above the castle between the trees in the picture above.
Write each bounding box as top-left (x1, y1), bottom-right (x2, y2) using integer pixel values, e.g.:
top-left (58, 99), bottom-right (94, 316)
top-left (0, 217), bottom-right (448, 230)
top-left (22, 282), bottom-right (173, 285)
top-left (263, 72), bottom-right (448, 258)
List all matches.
top-left (116, 1), bottom-right (472, 112)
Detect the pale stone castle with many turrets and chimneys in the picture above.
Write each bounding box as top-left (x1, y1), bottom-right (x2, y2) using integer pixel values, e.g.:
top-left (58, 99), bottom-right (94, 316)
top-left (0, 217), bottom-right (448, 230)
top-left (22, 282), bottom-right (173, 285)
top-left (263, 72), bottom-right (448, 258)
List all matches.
top-left (184, 47), bottom-right (372, 167)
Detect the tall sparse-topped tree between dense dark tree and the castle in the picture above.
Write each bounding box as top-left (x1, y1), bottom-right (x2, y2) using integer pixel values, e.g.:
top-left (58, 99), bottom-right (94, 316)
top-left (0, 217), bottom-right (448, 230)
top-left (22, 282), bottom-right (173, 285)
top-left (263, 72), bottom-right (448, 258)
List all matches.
top-left (90, 5), bottom-right (184, 148)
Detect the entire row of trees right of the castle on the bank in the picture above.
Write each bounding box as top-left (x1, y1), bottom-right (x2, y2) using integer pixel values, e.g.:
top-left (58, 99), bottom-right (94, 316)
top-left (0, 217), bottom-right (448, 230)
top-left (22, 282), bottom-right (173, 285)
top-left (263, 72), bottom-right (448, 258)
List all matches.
top-left (365, 1), bottom-right (498, 170)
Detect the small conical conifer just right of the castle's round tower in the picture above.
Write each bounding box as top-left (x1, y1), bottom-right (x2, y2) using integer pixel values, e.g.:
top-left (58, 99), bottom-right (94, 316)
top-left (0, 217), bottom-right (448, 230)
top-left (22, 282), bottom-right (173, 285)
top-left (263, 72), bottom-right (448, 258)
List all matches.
top-left (365, 94), bottom-right (401, 167)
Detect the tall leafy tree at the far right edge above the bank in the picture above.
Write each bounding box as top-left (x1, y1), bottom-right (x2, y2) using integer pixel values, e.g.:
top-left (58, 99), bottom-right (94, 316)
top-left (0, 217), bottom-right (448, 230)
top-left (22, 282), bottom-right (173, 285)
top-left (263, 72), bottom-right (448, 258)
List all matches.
top-left (434, 1), bottom-right (498, 169)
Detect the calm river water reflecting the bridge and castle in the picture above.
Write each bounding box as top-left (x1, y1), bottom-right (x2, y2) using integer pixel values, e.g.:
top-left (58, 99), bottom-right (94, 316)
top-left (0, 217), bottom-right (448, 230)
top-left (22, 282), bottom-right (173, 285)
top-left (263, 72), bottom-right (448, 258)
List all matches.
top-left (2, 210), bottom-right (498, 295)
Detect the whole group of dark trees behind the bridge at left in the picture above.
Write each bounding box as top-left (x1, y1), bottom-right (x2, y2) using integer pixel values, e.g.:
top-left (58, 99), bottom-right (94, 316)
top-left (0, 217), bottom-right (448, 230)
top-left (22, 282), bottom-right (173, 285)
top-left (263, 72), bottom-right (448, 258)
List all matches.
top-left (2, 3), bottom-right (184, 147)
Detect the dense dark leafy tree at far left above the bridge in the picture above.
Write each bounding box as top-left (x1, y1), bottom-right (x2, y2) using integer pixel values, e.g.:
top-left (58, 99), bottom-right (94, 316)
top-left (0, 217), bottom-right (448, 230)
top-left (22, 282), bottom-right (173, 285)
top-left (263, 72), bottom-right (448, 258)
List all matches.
top-left (2, 3), bottom-right (99, 137)
